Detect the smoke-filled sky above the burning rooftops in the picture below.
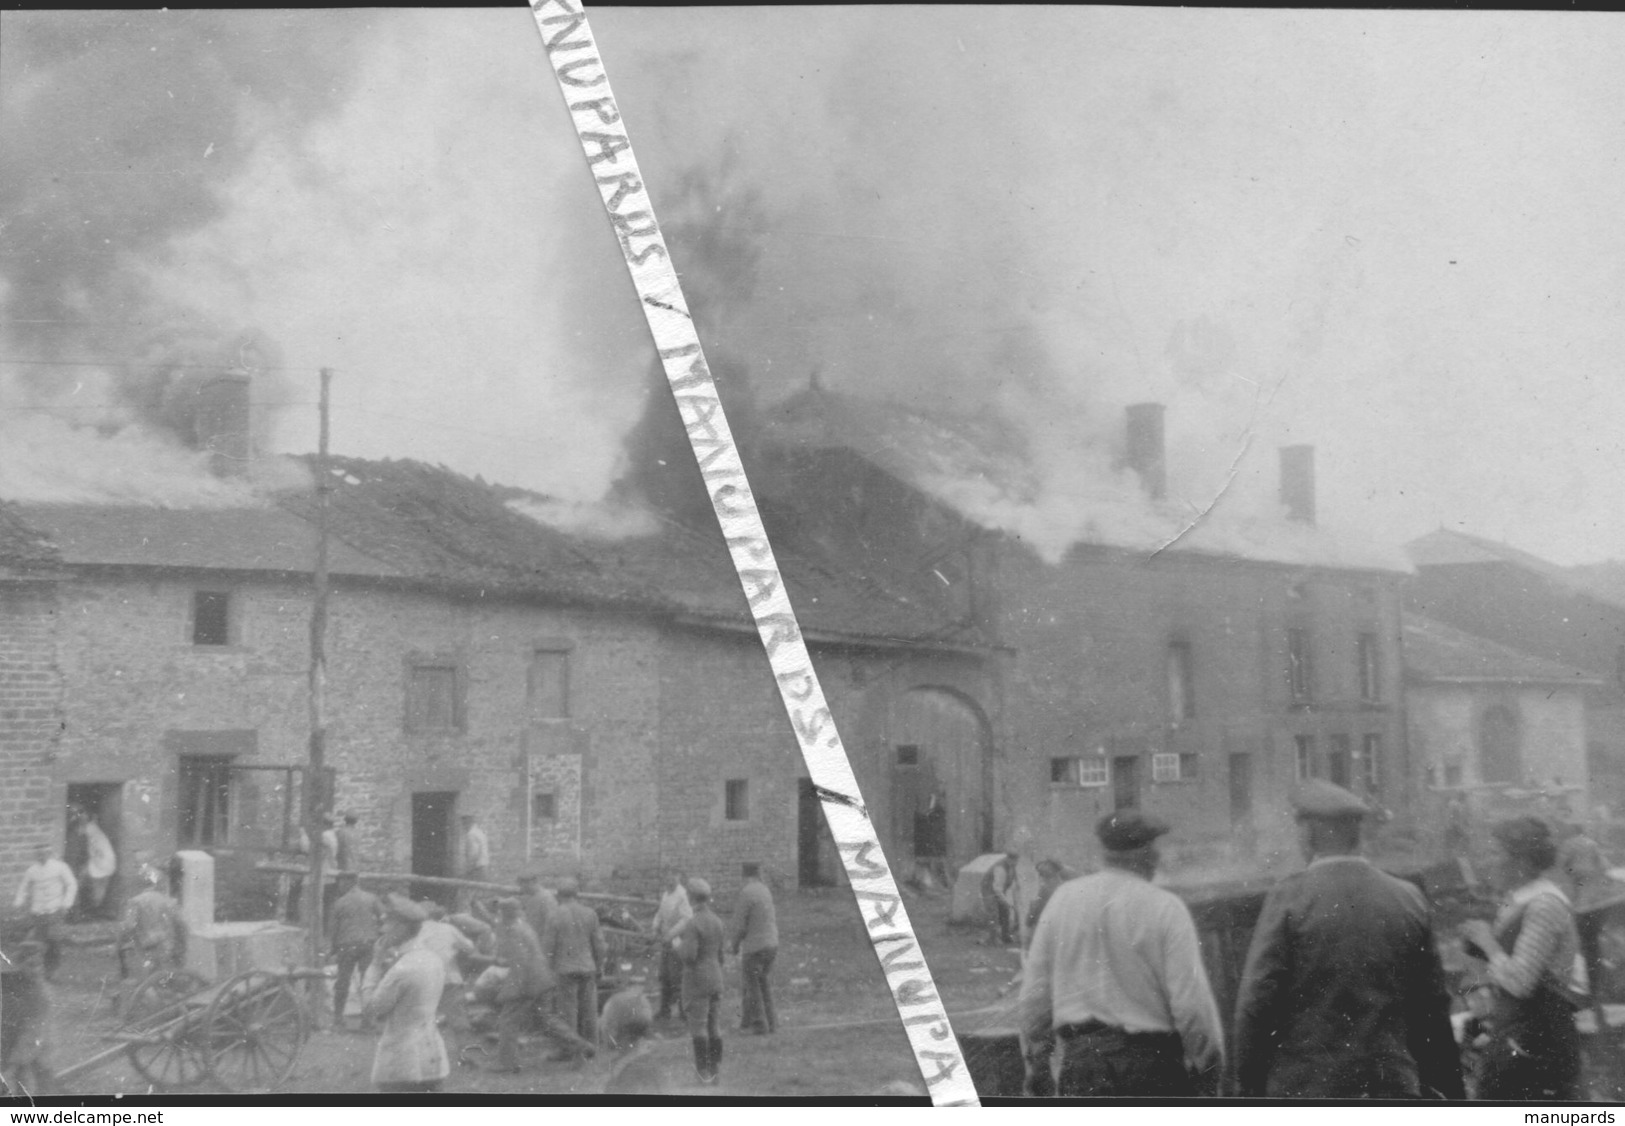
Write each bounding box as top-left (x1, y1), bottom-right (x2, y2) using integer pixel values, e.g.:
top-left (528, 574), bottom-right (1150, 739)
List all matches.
top-left (0, 6), bottom-right (1625, 564)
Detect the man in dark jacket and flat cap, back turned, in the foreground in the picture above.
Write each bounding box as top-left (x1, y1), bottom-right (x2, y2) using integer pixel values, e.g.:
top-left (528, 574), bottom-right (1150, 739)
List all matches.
top-left (1233, 778), bottom-right (1464, 1098)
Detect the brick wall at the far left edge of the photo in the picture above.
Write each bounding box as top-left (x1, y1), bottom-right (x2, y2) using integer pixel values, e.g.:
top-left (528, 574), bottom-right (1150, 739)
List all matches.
top-left (0, 582), bottom-right (63, 905)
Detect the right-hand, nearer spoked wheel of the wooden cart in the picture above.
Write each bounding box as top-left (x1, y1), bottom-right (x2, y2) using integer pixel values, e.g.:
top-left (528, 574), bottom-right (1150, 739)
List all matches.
top-left (202, 970), bottom-right (309, 1092)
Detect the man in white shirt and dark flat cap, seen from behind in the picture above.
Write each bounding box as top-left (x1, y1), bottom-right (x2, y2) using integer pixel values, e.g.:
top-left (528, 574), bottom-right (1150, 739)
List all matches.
top-left (1021, 809), bottom-right (1224, 1095)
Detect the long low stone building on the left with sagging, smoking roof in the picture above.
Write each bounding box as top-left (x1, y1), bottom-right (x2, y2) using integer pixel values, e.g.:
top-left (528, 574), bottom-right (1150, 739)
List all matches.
top-left (0, 458), bottom-right (990, 912)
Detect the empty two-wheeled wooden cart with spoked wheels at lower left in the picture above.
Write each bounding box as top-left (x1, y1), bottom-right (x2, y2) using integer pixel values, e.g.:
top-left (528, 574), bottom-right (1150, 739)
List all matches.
top-left (57, 968), bottom-right (327, 1094)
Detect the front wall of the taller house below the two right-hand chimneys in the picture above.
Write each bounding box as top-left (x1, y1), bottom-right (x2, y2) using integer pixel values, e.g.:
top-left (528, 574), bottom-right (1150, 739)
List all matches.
top-left (996, 548), bottom-right (1412, 874)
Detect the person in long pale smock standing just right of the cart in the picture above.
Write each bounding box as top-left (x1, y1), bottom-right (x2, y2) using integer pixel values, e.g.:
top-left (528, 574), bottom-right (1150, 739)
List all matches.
top-left (366, 895), bottom-right (452, 1092)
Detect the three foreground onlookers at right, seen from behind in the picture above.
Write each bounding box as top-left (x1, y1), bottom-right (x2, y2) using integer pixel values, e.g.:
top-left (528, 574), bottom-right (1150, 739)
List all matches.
top-left (1021, 780), bottom-right (1602, 1102)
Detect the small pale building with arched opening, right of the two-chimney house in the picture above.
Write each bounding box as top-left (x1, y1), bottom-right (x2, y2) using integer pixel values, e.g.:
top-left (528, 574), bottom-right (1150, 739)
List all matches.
top-left (1404, 613), bottom-right (1602, 835)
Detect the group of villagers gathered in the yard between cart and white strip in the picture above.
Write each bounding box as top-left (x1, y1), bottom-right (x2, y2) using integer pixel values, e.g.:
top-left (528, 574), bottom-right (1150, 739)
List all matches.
top-left (327, 844), bottom-right (778, 1092)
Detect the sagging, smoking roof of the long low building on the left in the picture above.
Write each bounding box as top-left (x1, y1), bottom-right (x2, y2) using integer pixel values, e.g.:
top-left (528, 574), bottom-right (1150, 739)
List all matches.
top-left (0, 458), bottom-right (980, 647)
